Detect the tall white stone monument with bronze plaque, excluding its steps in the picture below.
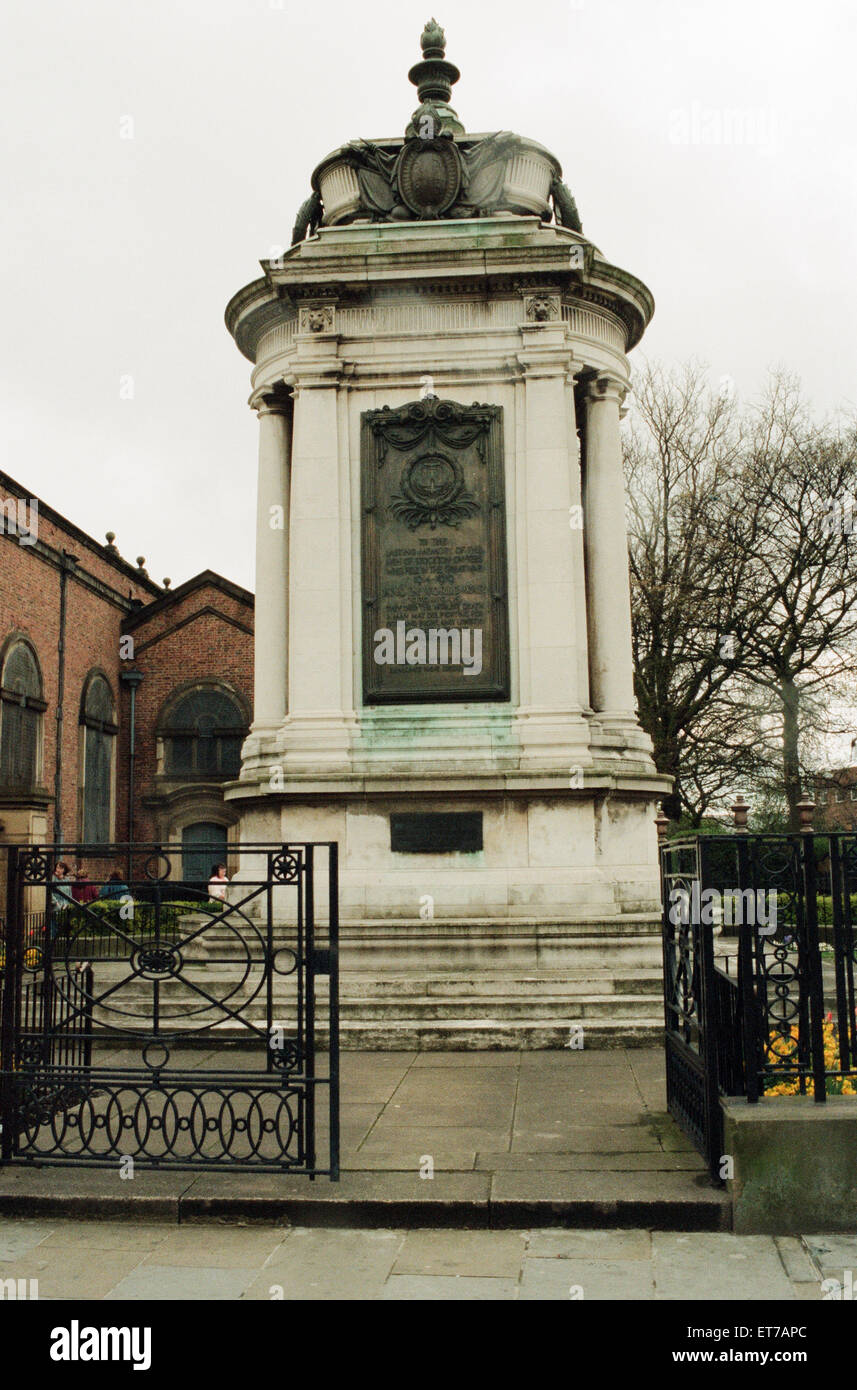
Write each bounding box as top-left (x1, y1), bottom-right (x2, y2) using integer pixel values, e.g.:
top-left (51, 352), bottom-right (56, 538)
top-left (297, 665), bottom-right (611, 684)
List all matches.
top-left (226, 16), bottom-right (667, 1006)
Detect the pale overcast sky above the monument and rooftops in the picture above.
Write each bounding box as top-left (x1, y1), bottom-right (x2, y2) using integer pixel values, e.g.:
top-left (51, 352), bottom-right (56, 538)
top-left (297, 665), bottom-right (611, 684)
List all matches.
top-left (0, 0), bottom-right (857, 588)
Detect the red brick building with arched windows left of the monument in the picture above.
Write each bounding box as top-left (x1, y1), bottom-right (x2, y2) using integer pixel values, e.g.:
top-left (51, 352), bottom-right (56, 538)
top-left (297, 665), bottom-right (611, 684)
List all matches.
top-left (0, 473), bottom-right (253, 881)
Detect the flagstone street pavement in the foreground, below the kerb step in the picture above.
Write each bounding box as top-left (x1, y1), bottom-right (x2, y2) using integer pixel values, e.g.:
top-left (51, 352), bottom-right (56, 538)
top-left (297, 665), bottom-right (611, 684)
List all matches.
top-left (0, 1218), bottom-right (857, 1305)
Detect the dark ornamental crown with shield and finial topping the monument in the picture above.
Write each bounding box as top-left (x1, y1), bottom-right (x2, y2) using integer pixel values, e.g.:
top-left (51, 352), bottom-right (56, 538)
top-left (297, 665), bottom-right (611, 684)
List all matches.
top-left (292, 19), bottom-right (582, 246)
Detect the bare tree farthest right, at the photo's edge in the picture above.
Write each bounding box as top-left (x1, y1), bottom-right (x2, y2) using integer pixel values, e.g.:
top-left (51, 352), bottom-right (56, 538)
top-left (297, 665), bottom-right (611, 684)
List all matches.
top-left (736, 373), bottom-right (857, 830)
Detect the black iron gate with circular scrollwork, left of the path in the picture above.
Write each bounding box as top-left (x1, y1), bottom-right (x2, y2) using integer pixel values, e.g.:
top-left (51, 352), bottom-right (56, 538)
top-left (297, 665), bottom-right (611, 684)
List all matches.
top-left (0, 842), bottom-right (339, 1179)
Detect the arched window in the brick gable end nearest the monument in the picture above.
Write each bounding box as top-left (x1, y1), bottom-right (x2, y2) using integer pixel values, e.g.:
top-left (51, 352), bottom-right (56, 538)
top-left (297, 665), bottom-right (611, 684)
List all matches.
top-left (161, 688), bottom-right (247, 778)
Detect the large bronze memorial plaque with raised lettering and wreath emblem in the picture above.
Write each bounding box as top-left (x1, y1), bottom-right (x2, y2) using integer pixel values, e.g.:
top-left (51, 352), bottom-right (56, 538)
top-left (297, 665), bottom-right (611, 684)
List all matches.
top-left (361, 396), bottom-right (508, 705)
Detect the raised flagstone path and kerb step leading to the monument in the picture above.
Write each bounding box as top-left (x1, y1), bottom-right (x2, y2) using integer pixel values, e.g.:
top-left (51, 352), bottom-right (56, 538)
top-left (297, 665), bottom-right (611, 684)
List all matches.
top-left (0, 1048), bottom-right (731, 1234)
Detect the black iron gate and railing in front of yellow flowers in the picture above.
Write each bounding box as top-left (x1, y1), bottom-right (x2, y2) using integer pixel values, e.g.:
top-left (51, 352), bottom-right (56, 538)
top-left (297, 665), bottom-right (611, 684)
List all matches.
top-left (661, 828), bottom-right (857, 1176)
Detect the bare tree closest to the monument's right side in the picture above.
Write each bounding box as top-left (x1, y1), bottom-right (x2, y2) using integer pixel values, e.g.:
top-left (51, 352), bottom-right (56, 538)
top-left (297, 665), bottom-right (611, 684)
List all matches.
top-left (625, 363), bottom-right (746, 820)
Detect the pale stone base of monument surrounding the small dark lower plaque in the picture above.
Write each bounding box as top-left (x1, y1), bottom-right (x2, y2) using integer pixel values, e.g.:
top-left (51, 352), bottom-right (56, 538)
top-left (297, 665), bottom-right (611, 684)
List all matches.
top-left (231, 780), bottom-right (658, 928)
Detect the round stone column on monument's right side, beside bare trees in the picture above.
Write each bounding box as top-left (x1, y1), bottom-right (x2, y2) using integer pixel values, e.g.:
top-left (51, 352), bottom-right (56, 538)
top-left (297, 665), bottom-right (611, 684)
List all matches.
top-left (583, 375), bottom-right (636, 723)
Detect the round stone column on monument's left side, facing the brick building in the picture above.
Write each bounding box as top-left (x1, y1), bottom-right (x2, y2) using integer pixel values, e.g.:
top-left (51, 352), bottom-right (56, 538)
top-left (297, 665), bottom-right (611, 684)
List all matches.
top-left (251, 391), bottom-right (292, 731)
